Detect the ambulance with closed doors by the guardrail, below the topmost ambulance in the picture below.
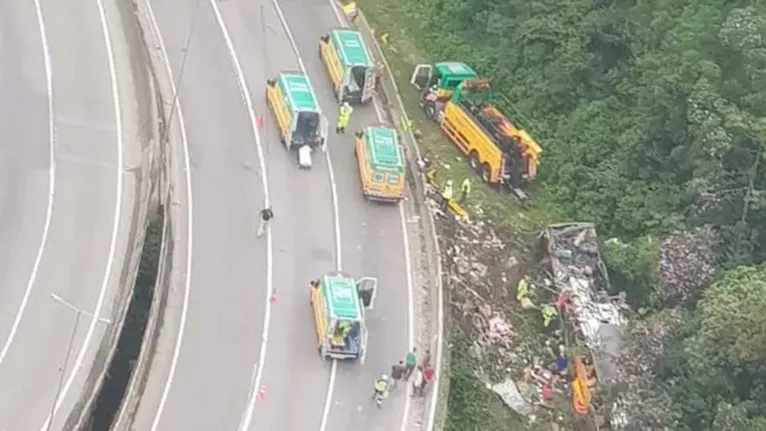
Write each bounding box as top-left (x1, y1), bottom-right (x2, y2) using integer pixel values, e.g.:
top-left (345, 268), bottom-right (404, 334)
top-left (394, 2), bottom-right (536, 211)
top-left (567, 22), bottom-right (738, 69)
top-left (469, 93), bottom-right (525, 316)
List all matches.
top-left (355, 126), bottom-right (406, 202)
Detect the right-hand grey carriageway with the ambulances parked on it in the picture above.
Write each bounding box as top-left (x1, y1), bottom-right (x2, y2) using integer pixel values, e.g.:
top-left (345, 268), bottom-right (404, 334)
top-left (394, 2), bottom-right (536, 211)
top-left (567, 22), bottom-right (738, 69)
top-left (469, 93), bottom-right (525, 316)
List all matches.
top-left (131, 0), bottom-right (420, 431)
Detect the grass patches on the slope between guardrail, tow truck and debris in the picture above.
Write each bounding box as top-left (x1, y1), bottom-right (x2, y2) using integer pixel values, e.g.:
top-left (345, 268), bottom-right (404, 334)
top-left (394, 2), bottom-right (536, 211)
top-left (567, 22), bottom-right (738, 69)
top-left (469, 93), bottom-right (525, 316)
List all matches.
top-left (357, 0), bottom-right (558, 431)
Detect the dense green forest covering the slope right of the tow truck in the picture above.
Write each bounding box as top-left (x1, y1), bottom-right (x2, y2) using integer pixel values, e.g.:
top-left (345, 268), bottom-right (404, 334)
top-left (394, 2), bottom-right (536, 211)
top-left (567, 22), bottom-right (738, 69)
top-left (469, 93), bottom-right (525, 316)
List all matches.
top-left (368, 0), bottom-right (766, 431)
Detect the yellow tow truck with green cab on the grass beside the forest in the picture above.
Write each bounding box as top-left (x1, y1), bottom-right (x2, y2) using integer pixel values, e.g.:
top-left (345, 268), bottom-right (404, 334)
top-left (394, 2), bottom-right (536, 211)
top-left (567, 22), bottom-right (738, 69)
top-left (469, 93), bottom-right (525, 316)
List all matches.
top-left (410, 62), bottom-right (542, 200)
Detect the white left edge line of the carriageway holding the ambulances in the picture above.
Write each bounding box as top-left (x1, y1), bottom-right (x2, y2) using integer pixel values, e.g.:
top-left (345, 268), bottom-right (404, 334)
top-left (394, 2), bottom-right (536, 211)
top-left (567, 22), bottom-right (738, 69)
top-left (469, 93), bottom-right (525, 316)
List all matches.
top-left (145, 0), bottom-right (194, 431)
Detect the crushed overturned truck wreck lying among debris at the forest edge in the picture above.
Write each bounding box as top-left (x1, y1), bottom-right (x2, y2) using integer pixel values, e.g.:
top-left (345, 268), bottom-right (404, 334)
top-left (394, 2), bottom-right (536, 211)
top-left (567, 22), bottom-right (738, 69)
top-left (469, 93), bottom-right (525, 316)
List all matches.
top-left (541, 223), bottom-right (628, 426)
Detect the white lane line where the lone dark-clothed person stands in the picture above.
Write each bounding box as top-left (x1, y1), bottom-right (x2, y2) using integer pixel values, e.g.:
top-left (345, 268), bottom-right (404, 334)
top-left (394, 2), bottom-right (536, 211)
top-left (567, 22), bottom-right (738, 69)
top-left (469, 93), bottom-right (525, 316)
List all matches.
top-left (204, 0), bottom-right (274, 430)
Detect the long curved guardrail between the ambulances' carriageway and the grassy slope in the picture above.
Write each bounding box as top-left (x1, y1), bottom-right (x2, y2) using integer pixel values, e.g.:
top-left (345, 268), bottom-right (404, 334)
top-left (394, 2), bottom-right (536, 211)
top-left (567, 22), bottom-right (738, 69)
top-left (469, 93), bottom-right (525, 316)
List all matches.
top-left (338, 3), bottom-right (449, 431)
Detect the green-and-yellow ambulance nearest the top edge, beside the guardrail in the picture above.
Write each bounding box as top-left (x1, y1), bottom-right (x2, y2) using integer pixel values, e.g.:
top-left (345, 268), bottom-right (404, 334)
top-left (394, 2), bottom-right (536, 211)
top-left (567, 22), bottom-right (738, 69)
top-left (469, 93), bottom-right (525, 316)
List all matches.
top-left (319, 28), bottom-right (376, 103)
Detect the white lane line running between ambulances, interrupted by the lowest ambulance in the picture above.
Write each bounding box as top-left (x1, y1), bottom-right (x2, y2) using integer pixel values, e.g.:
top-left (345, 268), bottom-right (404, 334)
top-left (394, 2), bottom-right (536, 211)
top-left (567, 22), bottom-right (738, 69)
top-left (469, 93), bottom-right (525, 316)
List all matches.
top-left (256, 0), bottom-right (343, 431)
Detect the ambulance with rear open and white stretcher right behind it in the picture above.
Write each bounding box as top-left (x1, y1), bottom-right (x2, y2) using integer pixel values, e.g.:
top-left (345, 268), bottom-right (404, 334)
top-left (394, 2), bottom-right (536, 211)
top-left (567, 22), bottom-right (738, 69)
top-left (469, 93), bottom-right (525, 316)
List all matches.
top-left (266, 72), bottom-right (328, 168)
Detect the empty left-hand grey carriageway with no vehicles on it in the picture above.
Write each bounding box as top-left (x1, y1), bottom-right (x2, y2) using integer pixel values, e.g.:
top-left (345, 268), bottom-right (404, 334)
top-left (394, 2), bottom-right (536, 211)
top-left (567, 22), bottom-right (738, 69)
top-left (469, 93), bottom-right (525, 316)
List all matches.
top-left (0, 0), bottom-right (138, 430)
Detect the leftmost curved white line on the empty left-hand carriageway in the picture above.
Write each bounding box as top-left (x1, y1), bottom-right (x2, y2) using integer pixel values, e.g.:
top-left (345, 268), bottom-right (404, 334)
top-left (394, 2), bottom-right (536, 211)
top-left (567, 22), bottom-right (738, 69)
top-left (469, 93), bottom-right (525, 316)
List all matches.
top-left (0, 0), bottom-right (56, 372)
